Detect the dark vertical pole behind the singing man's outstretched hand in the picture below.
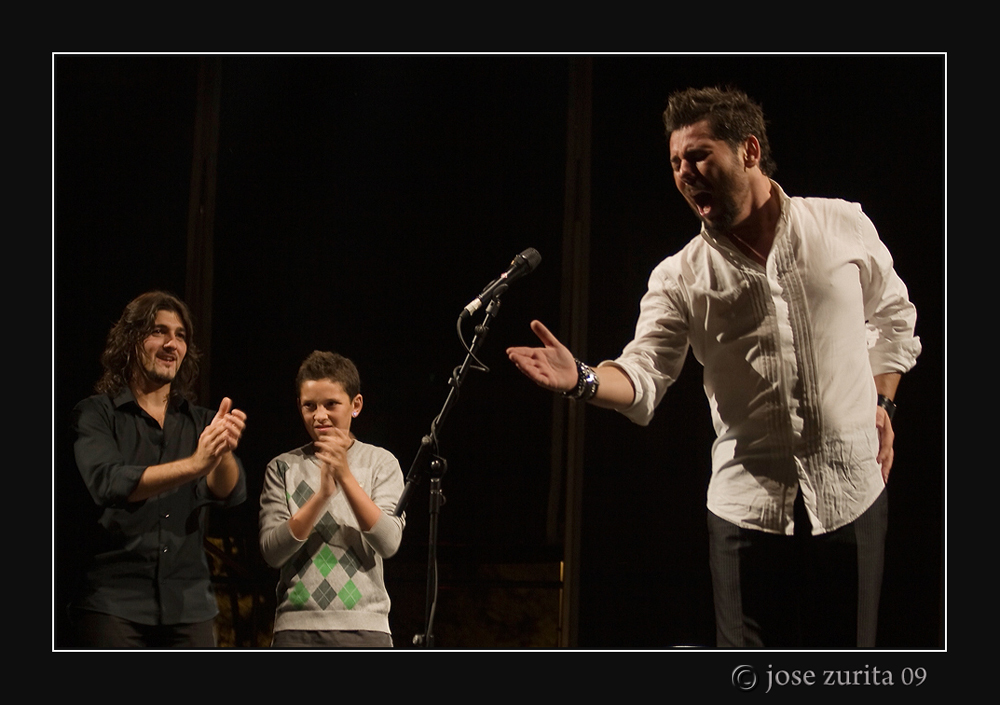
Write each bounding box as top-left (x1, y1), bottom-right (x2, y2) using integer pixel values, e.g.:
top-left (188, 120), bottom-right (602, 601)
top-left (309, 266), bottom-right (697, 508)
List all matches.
top-left (547, 57), bottom-right (593, 647)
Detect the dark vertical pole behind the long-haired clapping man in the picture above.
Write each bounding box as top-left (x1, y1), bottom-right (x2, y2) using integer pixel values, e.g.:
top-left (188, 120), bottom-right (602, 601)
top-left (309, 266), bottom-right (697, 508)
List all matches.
top-left (184, 56), bottom-right (222, 406)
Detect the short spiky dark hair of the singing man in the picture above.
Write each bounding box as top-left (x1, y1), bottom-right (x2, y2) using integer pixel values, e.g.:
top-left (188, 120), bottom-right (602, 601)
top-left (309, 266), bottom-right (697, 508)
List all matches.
top-left (663, 88), bottom-right (778, 176)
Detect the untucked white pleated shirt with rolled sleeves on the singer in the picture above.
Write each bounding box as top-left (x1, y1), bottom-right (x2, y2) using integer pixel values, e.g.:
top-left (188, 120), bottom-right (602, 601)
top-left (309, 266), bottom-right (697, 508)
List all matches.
top-left (600, 182), bottom-right (920, 534)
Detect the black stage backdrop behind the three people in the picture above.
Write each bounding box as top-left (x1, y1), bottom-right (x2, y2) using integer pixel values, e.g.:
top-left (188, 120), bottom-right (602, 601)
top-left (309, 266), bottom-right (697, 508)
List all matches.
top-left (53, 55), bottom-right (945, 648)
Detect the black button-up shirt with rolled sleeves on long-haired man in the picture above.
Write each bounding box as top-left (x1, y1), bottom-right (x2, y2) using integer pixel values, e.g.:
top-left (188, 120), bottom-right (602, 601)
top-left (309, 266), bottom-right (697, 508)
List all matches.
top-left (73, 389), bottom-right (246, 624)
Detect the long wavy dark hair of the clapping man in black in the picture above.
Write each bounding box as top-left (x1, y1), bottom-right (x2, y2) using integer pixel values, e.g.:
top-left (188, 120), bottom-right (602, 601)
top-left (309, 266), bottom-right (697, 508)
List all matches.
top-left (94, 291), bottom-right (201, 402)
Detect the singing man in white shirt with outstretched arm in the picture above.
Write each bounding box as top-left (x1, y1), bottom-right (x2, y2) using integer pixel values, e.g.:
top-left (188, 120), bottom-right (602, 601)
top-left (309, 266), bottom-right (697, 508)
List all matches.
top-left (507, 88), bottom-right (920, 647)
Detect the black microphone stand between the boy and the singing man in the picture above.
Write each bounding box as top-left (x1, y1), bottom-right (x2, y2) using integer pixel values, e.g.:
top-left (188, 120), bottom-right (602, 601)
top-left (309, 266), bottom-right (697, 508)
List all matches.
top-left (394, 286), bottom-right (507, 649)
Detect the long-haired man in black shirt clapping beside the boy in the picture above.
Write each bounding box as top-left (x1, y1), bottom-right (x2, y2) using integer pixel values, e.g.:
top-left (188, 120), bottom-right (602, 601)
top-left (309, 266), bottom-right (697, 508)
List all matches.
top-left (71, 291), bottom-right (246, 648)
